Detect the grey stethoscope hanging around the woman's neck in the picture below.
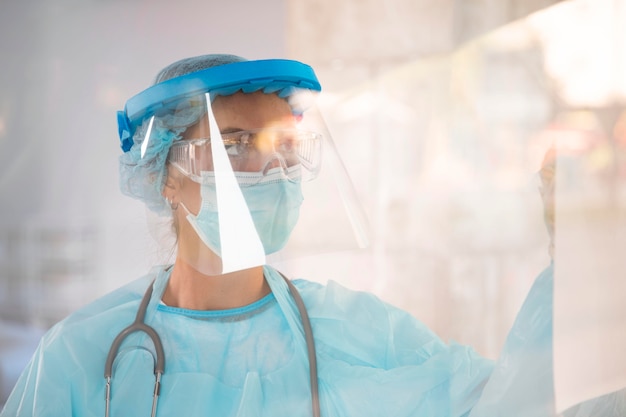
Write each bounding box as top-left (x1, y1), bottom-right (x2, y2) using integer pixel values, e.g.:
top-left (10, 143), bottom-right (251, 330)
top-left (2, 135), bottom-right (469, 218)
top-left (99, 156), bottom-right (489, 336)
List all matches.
top-left (104, 272), bottom-right (320, 417)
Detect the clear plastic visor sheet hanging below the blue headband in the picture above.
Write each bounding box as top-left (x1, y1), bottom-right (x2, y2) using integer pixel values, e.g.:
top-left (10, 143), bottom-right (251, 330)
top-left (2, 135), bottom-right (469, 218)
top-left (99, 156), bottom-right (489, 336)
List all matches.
top-left (133, 90), bottom-right (368, 275)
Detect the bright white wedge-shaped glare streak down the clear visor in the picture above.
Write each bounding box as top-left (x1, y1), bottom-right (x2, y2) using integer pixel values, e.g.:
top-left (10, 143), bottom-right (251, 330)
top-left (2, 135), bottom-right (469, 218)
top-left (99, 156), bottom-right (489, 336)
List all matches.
top-left (205, 93), bottom-right (265, 274)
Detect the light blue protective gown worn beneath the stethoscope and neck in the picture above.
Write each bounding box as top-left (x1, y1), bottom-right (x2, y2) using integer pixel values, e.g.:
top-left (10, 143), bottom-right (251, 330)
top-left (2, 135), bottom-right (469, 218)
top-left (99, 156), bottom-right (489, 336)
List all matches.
top-left (0, 267), bottom-right (493, 417)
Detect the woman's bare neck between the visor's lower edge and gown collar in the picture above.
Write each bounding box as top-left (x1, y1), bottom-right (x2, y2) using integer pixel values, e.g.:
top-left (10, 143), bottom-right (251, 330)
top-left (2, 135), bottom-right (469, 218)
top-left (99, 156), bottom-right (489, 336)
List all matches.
top-left (163, 258), bottom-right (270, 310)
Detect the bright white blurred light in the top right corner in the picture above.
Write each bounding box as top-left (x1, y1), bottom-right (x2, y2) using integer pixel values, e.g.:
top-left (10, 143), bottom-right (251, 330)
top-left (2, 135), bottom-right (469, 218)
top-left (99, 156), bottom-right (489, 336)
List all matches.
top-left (527, 0), bottom-right (626, 107)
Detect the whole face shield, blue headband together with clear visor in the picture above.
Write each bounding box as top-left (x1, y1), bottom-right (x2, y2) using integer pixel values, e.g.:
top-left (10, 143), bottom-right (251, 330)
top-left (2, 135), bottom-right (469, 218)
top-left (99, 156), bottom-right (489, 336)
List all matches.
top-left (118, 60), bottom-right (368, 275)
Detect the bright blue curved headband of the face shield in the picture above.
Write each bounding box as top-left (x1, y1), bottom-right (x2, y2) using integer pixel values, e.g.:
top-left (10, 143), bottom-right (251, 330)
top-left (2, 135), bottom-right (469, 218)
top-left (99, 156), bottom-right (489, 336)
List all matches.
top-left (117, 59), bottom-right (321, 152)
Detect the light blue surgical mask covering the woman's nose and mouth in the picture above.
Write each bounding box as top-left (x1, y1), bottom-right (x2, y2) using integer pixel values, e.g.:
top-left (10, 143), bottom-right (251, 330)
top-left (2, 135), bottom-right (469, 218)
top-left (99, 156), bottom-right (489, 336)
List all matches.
top-left (181, 170), bottom-right (303, 256)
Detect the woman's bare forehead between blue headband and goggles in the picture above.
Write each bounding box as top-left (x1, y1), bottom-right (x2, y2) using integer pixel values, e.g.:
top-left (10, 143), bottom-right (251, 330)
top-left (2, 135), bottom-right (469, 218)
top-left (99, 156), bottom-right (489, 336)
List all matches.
top-left (212, 91), bottom-right (293, 129)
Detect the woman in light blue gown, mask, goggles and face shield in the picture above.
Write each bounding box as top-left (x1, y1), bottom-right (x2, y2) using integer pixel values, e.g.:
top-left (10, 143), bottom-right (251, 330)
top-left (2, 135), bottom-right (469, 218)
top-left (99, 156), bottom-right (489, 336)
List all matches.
top-left (0, 55), bottom-right (492, 417)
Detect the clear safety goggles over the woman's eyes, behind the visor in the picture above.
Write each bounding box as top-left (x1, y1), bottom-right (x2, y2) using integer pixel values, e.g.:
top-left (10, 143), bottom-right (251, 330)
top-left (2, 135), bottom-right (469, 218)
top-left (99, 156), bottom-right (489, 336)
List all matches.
top-left (168, 128), bottom-right (322, 182)
